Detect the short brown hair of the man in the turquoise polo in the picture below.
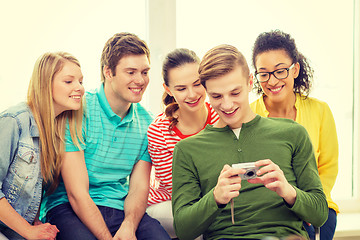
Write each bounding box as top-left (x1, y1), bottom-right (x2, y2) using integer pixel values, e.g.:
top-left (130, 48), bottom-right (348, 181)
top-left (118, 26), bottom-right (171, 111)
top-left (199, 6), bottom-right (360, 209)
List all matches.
top-left (100, 32), bottom-right (150, 82)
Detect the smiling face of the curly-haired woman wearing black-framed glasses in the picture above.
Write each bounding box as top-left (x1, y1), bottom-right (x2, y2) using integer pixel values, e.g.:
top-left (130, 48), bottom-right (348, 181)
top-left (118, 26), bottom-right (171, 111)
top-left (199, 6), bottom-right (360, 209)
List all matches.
top-left (255, 49), bottom-right (300, 103)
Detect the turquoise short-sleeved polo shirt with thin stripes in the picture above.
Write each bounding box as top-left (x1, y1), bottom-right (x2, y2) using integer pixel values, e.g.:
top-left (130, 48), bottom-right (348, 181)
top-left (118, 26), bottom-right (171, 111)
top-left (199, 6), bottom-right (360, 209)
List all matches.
top-left (46, 85), bottom-right (153, 210)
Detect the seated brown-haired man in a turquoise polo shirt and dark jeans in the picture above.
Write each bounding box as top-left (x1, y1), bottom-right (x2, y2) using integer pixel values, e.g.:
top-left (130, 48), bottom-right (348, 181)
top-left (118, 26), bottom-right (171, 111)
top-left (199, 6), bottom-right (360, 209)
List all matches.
top-left (42, 33), bottom-right (170, 240)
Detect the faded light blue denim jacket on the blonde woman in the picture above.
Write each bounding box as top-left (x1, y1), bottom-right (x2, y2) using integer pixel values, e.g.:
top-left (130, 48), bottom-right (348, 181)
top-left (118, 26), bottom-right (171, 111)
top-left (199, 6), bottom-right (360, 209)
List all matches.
top-left (0, 103), bottom-right (42, 224)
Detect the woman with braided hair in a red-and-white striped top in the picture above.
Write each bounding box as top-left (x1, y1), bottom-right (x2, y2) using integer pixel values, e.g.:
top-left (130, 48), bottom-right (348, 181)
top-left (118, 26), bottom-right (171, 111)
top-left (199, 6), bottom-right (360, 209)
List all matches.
top-left (147, 48), bottom-right (219, 237)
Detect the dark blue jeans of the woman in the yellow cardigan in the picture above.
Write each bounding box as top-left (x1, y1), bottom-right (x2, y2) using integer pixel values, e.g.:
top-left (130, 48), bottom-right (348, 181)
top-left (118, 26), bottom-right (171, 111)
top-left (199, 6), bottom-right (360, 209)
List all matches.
top-left (304, 208), bottom-right (337, 240)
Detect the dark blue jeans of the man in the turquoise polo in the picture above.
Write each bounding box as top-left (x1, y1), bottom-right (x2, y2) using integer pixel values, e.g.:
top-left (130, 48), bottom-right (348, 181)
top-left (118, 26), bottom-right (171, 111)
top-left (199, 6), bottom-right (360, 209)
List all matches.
top-left (46, 203), bottom-right (171, 240)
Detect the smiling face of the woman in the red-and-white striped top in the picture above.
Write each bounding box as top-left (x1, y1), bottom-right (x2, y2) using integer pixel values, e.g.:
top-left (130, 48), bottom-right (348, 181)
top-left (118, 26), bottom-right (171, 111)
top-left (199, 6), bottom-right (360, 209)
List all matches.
top-left (164, 63), bottom-right (206, 112)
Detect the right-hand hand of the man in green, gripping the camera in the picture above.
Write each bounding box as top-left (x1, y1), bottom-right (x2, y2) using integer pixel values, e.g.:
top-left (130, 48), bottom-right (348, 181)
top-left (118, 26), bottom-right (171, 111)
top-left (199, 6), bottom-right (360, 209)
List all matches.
top-left (248, 159), bottom-right (296, 206)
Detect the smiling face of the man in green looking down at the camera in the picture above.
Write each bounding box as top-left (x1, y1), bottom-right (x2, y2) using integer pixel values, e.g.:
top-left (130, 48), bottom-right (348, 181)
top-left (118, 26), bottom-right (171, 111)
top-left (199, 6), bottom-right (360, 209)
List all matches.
top-left (206, 66), bottom-right (254, 129)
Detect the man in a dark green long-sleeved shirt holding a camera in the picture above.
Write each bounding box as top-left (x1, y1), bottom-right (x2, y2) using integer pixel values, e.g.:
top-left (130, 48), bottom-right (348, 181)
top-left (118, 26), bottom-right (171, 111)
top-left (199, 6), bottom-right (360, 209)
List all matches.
top-left (172, 45), bottom-right (328, 240)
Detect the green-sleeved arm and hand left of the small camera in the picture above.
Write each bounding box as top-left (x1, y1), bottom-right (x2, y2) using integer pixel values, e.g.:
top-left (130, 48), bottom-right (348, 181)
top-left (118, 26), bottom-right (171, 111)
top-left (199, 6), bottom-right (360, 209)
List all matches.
top-left (172, 146), bottom-right (244, 239)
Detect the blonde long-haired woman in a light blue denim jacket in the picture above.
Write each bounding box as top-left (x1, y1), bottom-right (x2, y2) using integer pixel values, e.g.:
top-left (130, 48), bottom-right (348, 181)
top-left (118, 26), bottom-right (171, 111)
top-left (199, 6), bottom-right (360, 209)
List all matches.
top-left (0, 52), bottom-right (84, 239)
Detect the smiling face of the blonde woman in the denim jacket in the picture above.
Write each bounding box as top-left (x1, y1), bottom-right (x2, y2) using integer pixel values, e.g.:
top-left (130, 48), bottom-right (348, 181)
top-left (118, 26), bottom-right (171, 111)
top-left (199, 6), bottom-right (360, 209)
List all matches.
top-left (52, 60), bottom-right (84, 116)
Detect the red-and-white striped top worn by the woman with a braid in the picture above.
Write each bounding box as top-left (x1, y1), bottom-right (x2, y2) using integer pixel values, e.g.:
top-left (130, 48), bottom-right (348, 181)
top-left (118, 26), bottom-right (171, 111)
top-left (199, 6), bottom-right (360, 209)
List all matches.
top-left (147, 103), bottom-right (219, 205)
